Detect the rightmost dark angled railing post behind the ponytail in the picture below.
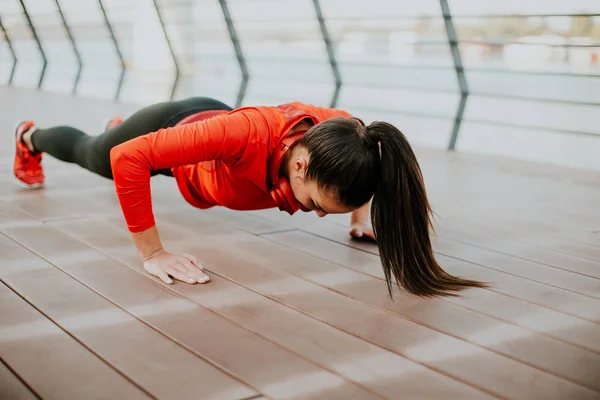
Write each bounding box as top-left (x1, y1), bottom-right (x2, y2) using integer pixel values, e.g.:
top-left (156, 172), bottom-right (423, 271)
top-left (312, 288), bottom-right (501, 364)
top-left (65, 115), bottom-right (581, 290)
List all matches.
top-left (440, 0), bottom-right (469, 150)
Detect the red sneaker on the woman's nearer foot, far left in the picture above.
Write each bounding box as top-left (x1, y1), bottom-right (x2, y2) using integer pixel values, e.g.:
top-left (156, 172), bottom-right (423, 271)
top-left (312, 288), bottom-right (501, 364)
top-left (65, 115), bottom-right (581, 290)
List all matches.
top-left (13, 121), bottom-right (44, 189)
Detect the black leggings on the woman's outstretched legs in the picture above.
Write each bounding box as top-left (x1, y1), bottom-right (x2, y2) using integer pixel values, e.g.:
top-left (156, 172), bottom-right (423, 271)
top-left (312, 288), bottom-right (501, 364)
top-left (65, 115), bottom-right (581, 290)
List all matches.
top-left (31, 97), bottom-right (231, 179)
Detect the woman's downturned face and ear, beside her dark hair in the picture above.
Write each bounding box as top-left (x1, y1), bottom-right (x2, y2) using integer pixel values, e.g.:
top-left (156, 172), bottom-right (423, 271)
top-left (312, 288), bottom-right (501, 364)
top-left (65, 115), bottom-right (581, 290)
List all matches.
top-left (288, 148), bottom-right (354, 217)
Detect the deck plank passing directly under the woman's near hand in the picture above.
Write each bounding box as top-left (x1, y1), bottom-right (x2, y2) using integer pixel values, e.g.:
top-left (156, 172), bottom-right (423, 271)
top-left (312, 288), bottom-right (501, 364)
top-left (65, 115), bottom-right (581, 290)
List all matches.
top-left (52, 220), bottom-right (494, 398)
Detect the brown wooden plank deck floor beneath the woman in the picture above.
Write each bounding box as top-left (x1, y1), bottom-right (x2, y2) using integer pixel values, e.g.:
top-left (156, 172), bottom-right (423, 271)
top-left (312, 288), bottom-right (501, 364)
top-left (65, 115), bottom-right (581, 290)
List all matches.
top-left (0, 88), bottom-right (600, 400)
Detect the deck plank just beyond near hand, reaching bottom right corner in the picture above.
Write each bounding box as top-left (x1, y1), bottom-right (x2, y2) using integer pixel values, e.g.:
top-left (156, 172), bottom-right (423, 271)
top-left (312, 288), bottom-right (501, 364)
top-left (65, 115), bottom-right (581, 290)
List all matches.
top-left (117, 215), bottom-right (597, 398)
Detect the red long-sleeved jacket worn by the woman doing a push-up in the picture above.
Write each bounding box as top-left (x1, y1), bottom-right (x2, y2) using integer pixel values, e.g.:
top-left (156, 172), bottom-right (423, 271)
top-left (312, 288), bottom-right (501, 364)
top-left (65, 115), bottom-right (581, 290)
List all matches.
top-left (110, 102), bottom-right (351, 232)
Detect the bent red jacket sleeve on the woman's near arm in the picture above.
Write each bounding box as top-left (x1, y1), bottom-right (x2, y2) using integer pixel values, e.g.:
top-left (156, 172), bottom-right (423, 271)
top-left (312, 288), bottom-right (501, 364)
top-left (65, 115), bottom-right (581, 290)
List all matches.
top-left (110, 109), bottom-right (268, 232)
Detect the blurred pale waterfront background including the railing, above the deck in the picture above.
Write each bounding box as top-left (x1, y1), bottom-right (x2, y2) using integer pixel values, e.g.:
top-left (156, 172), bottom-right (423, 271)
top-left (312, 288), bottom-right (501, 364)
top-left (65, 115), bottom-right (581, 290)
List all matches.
top-left (0, 0), bottom-right (600, 170)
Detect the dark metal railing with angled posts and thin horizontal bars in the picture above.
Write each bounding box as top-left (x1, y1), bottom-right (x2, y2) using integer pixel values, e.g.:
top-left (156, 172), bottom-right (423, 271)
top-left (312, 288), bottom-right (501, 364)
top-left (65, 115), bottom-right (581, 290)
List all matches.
top-left (0, 0), bottom-right (600, 150)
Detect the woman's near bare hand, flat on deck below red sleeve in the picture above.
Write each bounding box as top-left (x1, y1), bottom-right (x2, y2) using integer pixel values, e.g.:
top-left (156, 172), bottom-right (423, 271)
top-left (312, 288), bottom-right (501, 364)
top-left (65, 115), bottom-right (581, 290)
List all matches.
top-left (144, 250), bottom-right (210, 284)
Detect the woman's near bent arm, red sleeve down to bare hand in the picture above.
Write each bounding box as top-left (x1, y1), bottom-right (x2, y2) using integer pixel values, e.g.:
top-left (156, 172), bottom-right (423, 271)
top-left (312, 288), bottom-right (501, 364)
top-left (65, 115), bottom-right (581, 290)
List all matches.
top-left (110, 110), bottom-right (268, 283)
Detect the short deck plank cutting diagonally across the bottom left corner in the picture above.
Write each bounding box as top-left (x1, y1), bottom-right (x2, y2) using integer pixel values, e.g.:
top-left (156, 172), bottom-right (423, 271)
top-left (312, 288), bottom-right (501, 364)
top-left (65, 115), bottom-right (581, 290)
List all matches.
top-left (0, 284), bottom-right (149, 399)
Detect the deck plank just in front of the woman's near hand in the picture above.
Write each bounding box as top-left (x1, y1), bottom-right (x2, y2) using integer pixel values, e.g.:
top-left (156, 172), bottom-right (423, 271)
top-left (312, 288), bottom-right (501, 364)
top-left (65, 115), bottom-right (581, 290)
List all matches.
top-left (2, 216), bottom-right (377, 399)
